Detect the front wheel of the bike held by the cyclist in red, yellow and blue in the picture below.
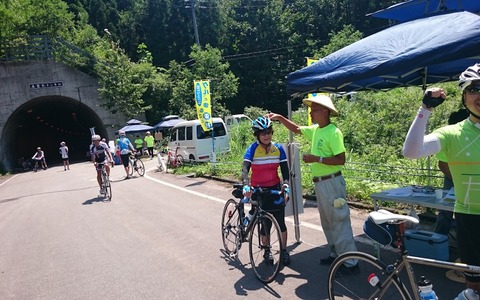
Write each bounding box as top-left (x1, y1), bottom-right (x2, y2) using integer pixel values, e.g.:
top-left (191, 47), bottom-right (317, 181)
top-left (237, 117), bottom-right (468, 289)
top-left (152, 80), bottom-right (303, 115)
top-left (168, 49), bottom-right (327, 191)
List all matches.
top-left (248, 213), bottom-right (283, 283)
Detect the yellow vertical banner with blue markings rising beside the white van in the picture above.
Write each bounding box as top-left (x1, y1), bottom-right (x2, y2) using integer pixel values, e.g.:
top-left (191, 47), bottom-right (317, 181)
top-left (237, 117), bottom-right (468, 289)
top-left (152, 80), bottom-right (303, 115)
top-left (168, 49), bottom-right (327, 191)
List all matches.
top-left (193, 80), bottom-right (213, 131)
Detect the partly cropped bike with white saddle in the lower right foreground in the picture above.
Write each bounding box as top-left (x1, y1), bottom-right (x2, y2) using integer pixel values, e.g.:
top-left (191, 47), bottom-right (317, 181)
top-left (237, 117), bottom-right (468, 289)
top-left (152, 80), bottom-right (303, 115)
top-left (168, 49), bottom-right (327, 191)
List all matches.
top-left (328, 210), bottom-right (480, 300)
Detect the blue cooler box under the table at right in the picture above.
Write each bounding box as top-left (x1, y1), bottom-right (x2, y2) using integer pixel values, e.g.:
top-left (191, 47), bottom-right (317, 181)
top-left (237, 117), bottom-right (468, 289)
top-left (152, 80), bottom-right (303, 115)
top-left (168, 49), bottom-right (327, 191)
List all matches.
top-left (405, 229), bottom-right (449, 261)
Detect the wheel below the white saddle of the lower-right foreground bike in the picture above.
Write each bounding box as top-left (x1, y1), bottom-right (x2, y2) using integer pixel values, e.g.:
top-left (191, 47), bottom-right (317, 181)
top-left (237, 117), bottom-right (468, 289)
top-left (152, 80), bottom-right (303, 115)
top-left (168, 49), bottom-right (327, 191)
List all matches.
top-left (328, 252), bottom-right (412, 300)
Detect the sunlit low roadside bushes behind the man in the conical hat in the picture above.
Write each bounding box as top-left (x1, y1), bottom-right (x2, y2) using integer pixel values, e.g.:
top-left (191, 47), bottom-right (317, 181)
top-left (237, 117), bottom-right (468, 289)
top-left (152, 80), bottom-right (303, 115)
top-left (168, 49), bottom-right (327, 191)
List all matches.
top-left (172, 83), bottom-right (461, 210)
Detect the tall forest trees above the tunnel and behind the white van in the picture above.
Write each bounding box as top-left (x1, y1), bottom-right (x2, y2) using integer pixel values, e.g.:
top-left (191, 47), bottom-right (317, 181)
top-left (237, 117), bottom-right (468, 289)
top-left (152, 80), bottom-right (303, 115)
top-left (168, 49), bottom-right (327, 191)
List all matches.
top-left (0, 0), bottom-right (398, 119)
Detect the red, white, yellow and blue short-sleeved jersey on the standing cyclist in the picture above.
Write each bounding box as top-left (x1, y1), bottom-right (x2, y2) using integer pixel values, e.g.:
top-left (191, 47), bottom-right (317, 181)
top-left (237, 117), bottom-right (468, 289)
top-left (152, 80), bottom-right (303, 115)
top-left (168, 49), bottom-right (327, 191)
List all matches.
top-left (243, 141), bottom-right (287, 187)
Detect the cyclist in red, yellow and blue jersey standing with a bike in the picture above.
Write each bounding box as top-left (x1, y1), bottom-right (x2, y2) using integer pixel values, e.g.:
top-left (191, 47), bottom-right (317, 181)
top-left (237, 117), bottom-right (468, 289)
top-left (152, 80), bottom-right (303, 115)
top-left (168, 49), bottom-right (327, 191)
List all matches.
top-left (242, 117), bottom-right (290, 266)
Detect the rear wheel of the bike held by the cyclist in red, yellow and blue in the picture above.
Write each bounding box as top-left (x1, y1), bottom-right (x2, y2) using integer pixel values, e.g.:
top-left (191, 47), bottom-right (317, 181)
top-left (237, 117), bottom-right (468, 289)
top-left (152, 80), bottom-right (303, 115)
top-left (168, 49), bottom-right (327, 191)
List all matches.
top-left (222, 199), bottom-right (242, 255)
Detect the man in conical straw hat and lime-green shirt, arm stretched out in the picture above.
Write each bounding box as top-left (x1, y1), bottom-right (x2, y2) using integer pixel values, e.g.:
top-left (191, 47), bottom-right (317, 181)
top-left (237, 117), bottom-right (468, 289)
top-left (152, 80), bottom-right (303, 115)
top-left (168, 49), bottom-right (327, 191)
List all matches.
top-left (267, 95), bottom-right (359, 273)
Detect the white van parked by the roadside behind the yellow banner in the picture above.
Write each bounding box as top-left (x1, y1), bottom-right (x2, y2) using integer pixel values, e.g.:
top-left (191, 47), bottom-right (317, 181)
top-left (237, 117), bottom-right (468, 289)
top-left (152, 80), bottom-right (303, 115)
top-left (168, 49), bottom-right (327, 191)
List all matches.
top-left (168, 118), bottom-right (230, 162)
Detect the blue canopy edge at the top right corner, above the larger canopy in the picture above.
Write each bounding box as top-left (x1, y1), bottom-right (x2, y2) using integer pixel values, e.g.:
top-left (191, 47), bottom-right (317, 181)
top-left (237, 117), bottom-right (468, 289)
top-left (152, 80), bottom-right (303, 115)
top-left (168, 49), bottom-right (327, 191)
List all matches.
top-left (367, 0), bottom-right (480, 22)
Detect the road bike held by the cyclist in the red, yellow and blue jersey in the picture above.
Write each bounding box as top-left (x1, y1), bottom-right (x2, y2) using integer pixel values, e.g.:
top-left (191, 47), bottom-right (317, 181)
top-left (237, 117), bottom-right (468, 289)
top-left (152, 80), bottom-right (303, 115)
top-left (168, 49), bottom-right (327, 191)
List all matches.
top-left (221, 184), bottom-right (283, 283)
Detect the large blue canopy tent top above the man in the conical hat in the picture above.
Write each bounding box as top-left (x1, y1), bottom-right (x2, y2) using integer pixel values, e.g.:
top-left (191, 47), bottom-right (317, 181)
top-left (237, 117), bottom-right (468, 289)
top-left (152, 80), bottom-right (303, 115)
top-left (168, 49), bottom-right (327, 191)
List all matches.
top-left (286, 12), bottom-right (480, 95)
